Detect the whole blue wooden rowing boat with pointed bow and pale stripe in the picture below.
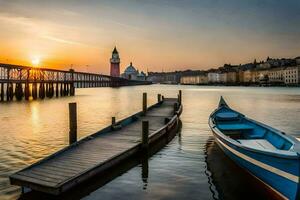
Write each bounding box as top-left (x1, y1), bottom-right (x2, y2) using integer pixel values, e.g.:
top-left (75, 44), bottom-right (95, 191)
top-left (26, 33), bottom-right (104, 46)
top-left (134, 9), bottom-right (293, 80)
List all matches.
top-left (209, 97), bottom-right (300, 200)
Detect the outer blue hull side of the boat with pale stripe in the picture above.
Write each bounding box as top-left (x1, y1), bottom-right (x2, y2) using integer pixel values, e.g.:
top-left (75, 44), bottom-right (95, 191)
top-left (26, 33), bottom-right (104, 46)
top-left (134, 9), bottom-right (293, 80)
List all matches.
top-left (213, 131), bottom-right (300, 199)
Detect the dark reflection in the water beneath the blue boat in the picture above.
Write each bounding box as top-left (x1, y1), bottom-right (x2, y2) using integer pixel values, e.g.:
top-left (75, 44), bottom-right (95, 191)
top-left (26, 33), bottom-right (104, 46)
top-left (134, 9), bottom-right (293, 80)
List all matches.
top-left (206, 137), bottom-right (272, 200)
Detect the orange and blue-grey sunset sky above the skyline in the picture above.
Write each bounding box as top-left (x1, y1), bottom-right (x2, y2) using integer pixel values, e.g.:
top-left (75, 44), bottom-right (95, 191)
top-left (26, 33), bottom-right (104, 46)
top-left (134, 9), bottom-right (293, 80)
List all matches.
top-left (0, 0), bottom-right (300, 74)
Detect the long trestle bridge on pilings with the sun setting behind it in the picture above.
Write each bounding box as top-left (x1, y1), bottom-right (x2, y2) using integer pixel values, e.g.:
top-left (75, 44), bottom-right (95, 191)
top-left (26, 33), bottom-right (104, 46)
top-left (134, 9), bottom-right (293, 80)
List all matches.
top-left (0, 63), bottom-right (151, 101)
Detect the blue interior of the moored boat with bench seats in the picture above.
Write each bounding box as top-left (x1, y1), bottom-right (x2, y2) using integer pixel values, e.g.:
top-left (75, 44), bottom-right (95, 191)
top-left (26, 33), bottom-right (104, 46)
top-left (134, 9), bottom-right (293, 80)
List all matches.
top-left (213, 107), bottom-right (293, 151)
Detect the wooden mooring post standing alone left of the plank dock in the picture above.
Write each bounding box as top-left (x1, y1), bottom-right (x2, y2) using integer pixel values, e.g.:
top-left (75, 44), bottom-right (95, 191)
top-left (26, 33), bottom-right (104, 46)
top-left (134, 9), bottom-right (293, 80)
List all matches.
top-left (69, 103), bottom-right (77, 145)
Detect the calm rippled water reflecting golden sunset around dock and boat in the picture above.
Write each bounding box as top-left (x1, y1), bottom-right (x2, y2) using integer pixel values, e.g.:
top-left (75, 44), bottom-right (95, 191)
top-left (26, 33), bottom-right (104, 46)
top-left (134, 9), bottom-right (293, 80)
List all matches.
top-left (0, 85), bottom-right (300, 199)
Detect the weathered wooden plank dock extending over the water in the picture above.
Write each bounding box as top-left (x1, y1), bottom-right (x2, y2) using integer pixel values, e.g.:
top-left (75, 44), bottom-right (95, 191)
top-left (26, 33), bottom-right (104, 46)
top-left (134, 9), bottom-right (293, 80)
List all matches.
top-left (10, 93), bottom-right (182, 195)
